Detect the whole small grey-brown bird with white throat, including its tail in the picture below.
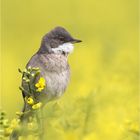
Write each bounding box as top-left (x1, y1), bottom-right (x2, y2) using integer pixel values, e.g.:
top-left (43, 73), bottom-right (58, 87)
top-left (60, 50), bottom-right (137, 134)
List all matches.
top-left (10, 27), bottom-right (81, 140)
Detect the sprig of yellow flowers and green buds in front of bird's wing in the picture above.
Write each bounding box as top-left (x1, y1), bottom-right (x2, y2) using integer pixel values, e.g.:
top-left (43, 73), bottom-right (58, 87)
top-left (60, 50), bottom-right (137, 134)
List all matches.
top-left (19, 66), bottom-right (46, 110)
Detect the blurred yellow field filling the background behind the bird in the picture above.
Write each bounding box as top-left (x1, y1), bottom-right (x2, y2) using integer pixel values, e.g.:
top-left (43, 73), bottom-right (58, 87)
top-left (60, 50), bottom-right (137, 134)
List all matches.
top-left (0, 0), bottom-right (139, 140)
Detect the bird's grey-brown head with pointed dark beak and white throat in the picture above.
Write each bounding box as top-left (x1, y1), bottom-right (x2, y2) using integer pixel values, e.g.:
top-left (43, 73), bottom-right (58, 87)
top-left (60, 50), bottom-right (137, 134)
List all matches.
top-left (39, 27), bottom-right (81, 54)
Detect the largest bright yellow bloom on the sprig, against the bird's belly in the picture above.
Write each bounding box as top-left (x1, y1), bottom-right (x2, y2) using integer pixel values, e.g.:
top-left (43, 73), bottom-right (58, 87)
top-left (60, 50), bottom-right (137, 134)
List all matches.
top-left (35, 77), bottom-right (45, 92)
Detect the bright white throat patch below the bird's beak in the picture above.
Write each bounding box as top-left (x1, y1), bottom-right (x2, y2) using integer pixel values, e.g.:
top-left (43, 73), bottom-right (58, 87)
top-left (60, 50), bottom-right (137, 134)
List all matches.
top-left (52, 43), bottom-right (74, 53)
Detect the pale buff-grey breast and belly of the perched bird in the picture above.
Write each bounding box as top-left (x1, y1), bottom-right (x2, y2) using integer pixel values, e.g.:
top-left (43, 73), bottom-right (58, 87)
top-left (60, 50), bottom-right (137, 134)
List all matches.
top-left (40, 54), bottom-right (70, 97)
